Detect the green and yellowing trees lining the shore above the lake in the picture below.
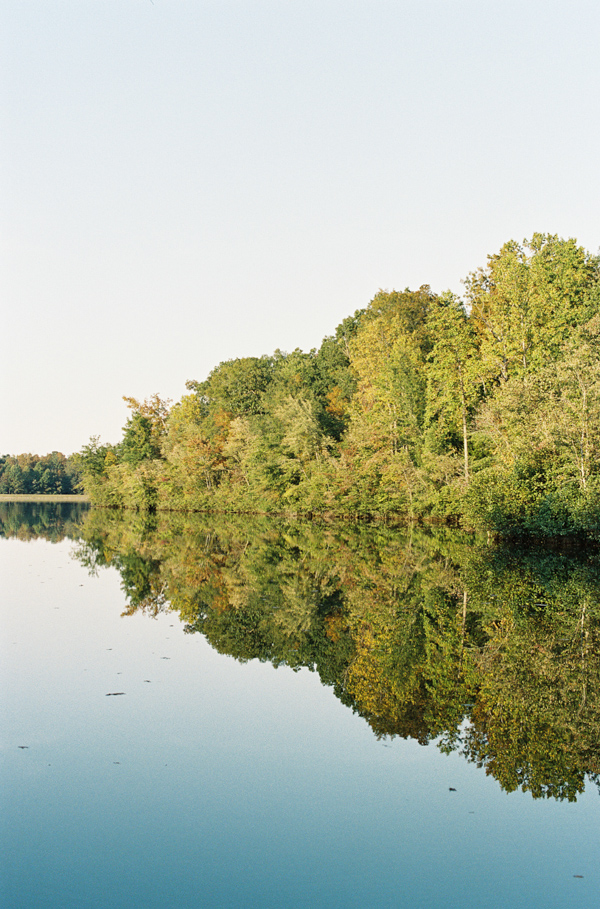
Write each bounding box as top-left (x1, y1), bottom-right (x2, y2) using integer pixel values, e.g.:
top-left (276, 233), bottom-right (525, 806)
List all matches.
top-left (0, 234), bottom-right (600, 539)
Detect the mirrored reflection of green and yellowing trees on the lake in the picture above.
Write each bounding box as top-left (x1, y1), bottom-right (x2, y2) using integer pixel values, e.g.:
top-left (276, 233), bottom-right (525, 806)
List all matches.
top-left (18, 510), bottom-right (600, 800)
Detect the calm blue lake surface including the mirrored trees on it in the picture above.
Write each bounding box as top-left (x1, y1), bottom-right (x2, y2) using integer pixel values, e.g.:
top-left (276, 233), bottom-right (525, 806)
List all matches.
top-left (0, 504), bottom-right (600, 909)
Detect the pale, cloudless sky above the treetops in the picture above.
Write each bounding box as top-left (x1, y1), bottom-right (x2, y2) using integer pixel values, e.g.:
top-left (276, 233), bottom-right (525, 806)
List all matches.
top-left (0, 0), bottom-right (600, 454)
